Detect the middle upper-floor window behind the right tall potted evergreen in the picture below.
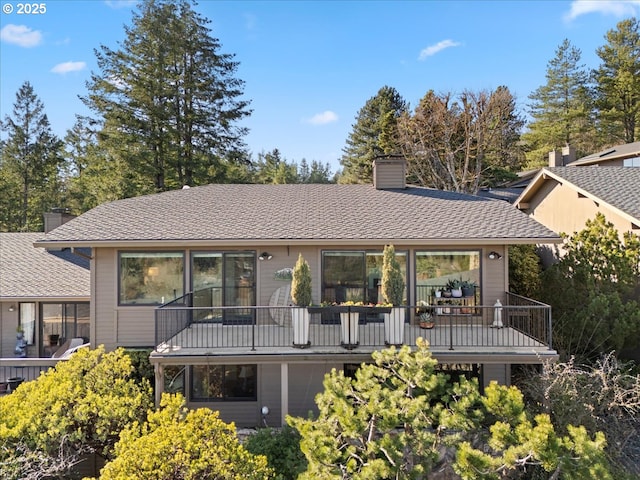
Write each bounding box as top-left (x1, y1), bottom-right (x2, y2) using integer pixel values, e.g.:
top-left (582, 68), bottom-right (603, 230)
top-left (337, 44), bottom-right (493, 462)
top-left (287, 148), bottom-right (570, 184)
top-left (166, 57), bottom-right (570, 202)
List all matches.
top-left (322, 251), bottom-right (407, 303)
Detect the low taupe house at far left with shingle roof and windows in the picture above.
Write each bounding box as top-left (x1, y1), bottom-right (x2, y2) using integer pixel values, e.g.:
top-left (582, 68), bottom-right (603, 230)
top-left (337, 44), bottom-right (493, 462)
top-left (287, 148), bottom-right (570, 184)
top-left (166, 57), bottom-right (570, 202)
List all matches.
top-left (0, 218), bottom-right (90, 386)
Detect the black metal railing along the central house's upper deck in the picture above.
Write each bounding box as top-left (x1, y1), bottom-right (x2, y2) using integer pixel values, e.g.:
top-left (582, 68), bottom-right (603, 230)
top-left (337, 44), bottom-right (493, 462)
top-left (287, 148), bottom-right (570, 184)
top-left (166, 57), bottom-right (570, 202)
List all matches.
top-left (155, 294), bottom-right (552, 353)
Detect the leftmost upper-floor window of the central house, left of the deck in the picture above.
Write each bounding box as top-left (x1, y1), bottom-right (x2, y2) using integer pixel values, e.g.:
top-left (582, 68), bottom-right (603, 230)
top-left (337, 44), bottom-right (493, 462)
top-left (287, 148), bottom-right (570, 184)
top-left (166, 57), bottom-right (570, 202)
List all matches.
top-left (119, 252), bottom-right (184, 305)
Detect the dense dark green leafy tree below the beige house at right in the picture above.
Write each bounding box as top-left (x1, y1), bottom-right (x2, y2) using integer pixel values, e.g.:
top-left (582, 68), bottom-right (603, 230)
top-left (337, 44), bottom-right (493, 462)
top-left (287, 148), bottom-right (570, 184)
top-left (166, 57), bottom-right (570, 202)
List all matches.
top-left (542, 213), bottom-right (640, 361)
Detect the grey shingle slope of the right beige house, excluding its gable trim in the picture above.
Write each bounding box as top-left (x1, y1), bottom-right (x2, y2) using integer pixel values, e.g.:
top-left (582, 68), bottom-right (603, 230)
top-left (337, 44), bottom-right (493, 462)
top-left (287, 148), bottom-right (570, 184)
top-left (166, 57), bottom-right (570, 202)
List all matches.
top-left (548, 166), bottom-right (640, 220)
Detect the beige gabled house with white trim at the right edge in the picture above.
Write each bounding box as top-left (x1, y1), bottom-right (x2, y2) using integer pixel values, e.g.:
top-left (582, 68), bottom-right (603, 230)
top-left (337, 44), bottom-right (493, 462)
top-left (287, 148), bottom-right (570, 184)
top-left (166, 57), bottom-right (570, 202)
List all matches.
top-left (515, 165), bottom-right (640, 244)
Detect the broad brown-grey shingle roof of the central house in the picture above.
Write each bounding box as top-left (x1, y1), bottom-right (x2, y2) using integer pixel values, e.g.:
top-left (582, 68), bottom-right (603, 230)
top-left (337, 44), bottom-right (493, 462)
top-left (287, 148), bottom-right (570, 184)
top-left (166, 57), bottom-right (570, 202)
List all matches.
top-left (35, 184), bottom-right (559, 246)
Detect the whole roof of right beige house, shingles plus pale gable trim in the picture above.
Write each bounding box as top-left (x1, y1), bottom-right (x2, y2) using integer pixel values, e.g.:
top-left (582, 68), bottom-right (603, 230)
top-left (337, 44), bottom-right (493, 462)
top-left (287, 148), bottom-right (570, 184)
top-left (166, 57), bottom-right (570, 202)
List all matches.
top-left (516, 166), bottom-right (640, 223)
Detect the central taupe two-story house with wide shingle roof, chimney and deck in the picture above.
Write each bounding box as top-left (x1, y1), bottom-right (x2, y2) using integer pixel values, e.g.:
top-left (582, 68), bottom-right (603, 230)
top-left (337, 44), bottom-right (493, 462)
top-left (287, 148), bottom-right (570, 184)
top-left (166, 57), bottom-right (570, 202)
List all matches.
top-left (36, 159), bottom-right (560, 426)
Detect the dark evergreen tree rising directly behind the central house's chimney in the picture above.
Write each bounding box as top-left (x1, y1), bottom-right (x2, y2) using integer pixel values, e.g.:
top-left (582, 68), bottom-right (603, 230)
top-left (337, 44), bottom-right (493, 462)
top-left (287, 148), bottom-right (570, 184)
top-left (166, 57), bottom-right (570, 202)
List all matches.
top-left (339, 86), bottom-right (408, 183)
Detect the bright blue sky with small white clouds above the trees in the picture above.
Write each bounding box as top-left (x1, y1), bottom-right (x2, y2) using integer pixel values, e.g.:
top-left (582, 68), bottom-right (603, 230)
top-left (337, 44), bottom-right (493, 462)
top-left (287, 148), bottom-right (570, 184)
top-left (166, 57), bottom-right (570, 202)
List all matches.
top-left (0, 0), bottom-right (640, 171)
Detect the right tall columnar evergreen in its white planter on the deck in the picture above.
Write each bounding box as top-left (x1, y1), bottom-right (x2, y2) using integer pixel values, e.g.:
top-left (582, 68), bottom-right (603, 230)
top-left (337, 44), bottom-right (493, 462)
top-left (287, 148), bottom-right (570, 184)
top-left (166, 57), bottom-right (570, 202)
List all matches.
top-left (382, 245), bottom-right (405, 345)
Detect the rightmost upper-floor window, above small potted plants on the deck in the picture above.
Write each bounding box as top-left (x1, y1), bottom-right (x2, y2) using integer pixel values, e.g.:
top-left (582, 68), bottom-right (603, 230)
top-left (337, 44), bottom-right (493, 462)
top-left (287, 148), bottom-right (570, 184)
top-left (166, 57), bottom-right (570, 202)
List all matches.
top-left (416, 250), bottom-right (480, 302)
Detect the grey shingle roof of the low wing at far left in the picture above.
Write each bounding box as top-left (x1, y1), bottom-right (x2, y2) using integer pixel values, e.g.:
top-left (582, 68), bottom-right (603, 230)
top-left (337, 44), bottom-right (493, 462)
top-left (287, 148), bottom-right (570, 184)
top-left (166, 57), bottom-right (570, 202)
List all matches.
top-left (0, 233), bottom-right (90, 299)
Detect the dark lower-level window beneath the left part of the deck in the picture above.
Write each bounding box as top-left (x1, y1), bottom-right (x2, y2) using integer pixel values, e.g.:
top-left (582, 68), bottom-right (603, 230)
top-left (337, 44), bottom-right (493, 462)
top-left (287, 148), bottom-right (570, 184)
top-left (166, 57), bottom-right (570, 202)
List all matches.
top-left (191, 365), bottom-right (257, 402)
